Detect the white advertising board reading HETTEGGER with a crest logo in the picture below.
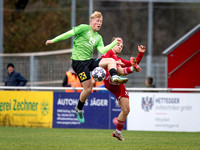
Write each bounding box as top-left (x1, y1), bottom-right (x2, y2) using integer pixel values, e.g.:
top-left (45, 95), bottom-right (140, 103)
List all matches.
top-left (127, 92), bottom-right (200, 132)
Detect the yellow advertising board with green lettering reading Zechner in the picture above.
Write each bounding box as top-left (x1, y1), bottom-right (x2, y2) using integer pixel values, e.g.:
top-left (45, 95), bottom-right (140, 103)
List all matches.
top-left (0, 91), bottom-right (53, 128)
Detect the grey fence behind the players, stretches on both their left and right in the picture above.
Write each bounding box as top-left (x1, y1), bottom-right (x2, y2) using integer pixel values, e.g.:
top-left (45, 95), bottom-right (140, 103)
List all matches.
top-left (0, 49), bottom-right (167, 87)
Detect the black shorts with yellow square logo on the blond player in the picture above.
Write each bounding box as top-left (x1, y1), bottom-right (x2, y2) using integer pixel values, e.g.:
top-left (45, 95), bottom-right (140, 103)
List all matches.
top-left (72, 58), bottom-right (101, 82)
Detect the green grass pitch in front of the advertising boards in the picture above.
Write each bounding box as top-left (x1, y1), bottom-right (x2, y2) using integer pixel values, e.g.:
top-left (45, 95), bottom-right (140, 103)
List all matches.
top-left (0, 127), bottom-right (200, 150)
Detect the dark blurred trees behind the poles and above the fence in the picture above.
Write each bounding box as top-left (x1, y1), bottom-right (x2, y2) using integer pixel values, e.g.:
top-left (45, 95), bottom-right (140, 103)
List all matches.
top-left (4, 0), bottom-right (200, 55)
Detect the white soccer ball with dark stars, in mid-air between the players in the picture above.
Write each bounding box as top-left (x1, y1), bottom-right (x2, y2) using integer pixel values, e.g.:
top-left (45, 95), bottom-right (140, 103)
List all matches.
top-left (92, 67), bottom-right (106, 81)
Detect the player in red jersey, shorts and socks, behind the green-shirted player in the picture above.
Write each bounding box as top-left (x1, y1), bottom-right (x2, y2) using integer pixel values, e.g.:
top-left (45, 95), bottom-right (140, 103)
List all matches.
top-left (101, 37), bottom-right (145, 141)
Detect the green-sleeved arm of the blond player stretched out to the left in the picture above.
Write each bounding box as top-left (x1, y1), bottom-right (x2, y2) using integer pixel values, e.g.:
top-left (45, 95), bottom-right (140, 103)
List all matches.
top-left (45, 29), bottom-right (75, 45)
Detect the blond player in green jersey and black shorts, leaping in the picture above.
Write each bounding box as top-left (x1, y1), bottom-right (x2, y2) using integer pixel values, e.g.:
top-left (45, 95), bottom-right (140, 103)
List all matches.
top-left (46, 11), bottom-right (128, 123)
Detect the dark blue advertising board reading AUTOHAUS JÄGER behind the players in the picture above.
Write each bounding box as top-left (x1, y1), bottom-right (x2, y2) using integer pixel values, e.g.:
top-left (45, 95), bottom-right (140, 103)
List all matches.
top-left (53, 92), bottom-right (126, 129)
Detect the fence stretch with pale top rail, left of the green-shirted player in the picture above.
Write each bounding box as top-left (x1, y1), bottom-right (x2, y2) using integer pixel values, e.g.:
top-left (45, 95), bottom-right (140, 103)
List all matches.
top-left (0, 49), bottom-right (72, 86)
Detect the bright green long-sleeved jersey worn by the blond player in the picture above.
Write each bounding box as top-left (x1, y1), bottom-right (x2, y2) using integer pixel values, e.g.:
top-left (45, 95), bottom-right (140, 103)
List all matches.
top-left (52, 24), bottom-right (117, 61)
